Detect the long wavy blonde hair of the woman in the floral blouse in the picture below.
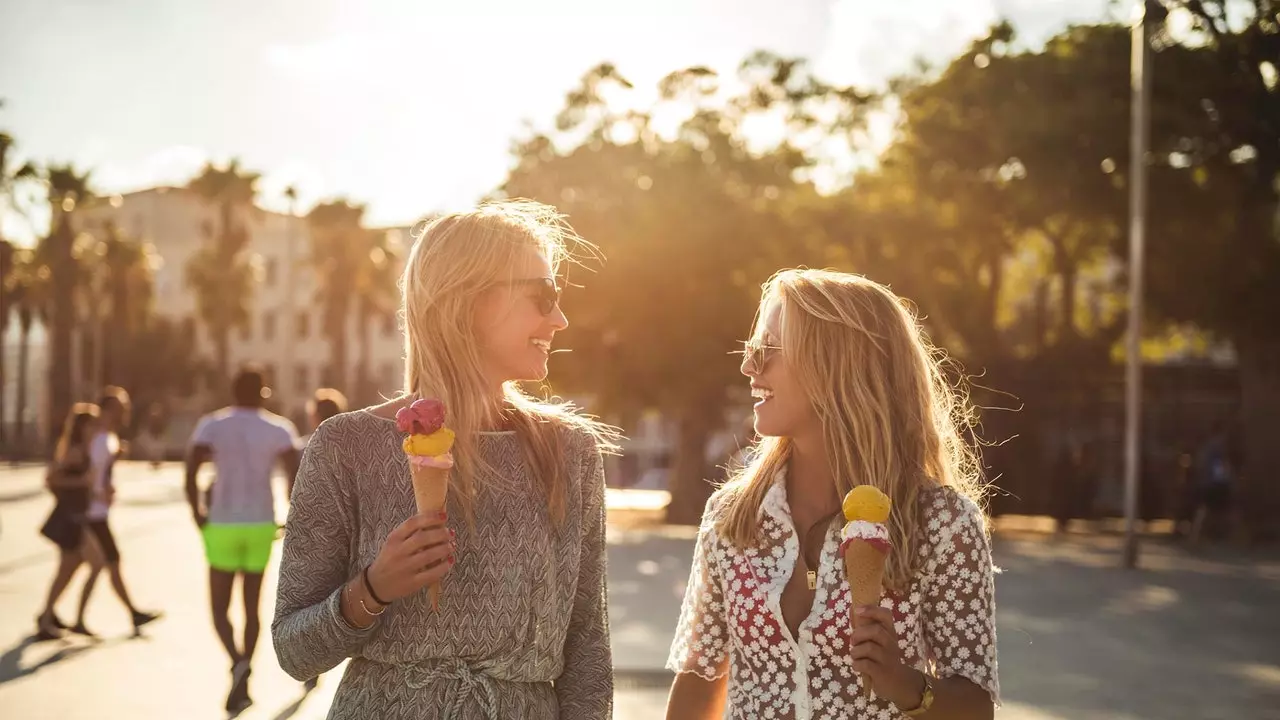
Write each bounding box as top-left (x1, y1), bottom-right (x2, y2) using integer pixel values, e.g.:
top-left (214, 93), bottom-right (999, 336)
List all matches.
top-left (717, 270), bottom-right (986, 591)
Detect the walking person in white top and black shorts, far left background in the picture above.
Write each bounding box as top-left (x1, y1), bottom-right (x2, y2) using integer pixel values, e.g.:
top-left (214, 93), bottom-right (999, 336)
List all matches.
top-left (72, 386), bottom-right (160, 637)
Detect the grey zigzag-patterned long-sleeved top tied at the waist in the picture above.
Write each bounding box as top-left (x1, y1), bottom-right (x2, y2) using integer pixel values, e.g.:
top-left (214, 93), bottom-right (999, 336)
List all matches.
top-left (271, 411), bottom-right (613, 720)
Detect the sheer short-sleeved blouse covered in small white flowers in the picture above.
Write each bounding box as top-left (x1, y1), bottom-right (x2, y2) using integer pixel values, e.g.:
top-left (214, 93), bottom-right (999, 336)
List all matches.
top-left (667, 473), bottom-right (1000, 720)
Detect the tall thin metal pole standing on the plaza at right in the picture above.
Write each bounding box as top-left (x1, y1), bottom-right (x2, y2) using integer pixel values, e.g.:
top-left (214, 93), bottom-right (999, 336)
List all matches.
top-left (1124, 0), bottom-right (1162, 569)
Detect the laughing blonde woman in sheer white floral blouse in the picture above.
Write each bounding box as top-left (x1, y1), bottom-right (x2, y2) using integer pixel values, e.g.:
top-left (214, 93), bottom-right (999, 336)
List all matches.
top-left (667, 270), bottom-right (1000, 720)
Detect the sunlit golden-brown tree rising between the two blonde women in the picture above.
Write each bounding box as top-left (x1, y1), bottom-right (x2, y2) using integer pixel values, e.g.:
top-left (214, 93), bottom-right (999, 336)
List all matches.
top-left (502, 55), bottom-right (870, 523)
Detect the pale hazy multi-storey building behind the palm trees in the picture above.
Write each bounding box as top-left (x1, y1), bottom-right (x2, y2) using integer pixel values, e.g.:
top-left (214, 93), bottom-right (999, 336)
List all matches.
top-left (76, 187), bottom-right (408, 430)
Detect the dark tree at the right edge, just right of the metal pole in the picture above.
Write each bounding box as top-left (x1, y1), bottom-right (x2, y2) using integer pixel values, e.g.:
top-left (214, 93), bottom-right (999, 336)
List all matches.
top-left (1148, 0), bottom-right (1280, 539)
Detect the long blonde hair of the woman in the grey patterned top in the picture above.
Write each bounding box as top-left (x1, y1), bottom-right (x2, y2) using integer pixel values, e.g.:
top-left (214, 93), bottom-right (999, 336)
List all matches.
top-left (401, 200), bottom-right (618, 528)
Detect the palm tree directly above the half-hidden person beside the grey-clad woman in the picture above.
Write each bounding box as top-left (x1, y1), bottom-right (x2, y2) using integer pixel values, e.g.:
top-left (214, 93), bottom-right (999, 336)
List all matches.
top-left (307, 200), bottom-right (370, 392)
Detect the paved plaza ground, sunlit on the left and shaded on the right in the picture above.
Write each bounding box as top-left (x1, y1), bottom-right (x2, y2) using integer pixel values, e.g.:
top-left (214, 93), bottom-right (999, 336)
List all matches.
top-left (0, 462), bottom-right (1280, 720)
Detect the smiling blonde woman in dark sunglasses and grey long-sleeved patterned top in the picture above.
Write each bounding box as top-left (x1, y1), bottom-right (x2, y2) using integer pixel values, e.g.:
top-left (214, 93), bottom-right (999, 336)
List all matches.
top-left (271, 201), bottom-right (616, 720)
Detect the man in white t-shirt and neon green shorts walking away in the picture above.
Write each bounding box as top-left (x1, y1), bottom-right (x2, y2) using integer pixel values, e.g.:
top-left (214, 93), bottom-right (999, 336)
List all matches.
top-left (187, 368), bottom-right (298, 712)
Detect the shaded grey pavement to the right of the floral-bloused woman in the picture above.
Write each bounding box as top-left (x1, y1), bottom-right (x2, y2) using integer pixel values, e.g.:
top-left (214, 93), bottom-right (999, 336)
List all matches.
top-left (996, 536), bottom-right (1280, 720)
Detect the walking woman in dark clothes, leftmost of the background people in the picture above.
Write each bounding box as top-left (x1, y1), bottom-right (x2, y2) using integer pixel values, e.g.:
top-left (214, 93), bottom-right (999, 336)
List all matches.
top-left (36, 402), bottom-right (101, 641)
